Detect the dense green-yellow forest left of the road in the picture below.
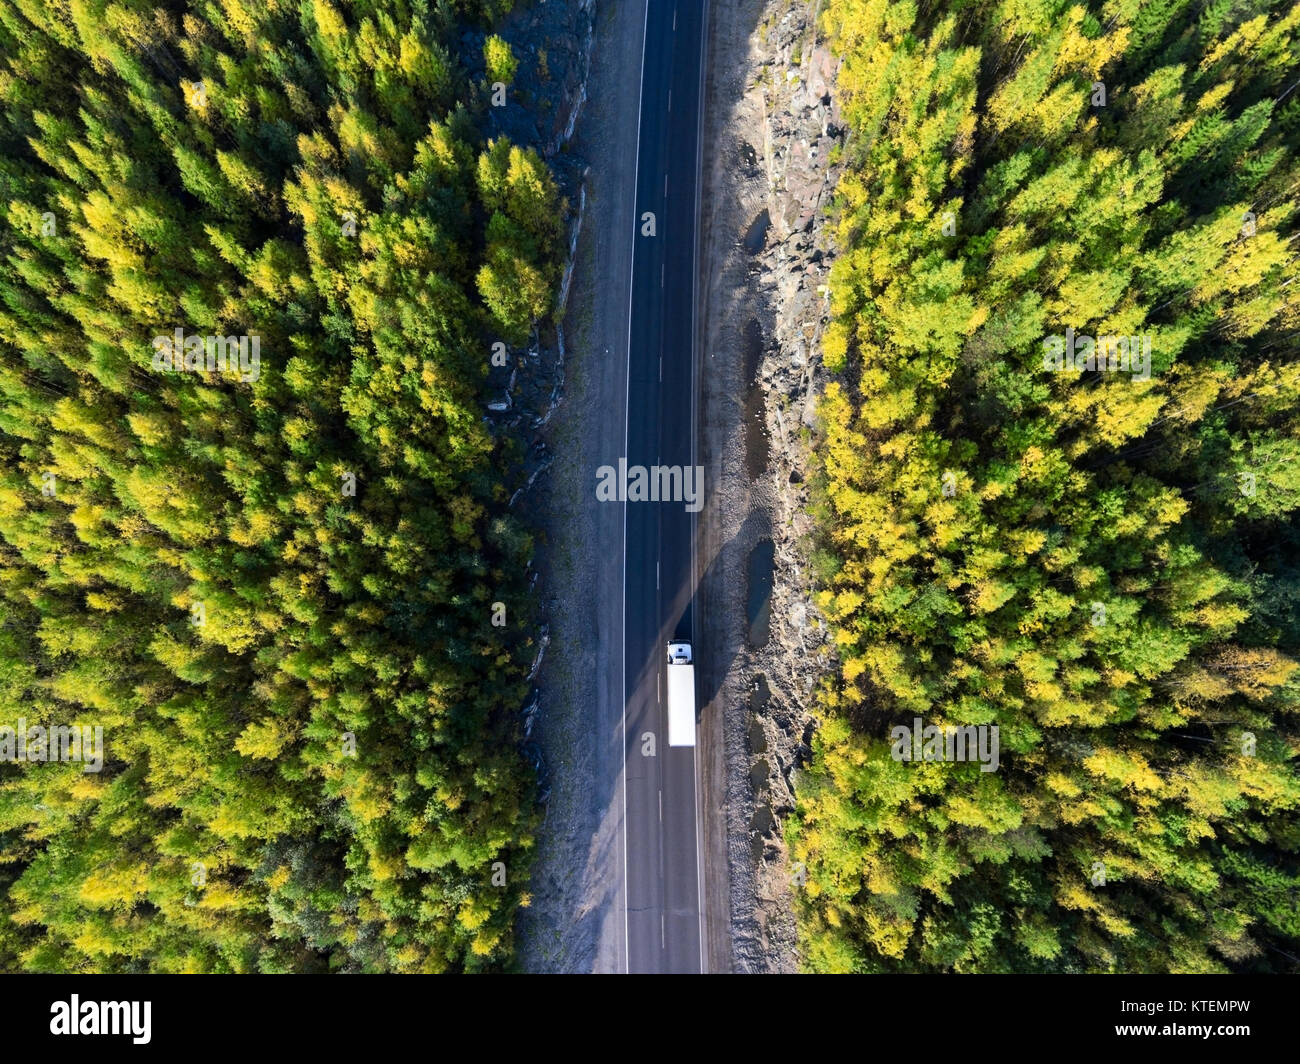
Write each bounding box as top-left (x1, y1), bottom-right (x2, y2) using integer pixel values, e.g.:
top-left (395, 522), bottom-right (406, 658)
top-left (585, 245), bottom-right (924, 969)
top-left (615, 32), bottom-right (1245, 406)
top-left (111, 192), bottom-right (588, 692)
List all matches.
top-left (0, 0), bottom-right (564, 972)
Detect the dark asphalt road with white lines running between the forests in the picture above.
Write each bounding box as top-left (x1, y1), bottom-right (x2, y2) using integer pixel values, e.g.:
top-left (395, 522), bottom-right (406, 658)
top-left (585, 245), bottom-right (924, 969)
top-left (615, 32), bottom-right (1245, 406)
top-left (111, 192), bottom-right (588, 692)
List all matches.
top-left (623, 0), bottom-right (707, 972)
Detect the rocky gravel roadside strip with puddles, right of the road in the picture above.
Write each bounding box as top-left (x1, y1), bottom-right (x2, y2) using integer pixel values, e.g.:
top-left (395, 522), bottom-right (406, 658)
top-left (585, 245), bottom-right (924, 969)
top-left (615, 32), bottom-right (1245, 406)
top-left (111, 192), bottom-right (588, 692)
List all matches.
top-left (697, 0), bottom-right (842, 972)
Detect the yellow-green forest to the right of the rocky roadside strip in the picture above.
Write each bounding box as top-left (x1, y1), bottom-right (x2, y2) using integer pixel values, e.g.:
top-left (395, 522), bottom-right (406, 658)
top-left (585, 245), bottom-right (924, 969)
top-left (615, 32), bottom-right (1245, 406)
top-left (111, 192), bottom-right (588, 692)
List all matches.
top-left (787, 0), bottom-right (1300, 973)
